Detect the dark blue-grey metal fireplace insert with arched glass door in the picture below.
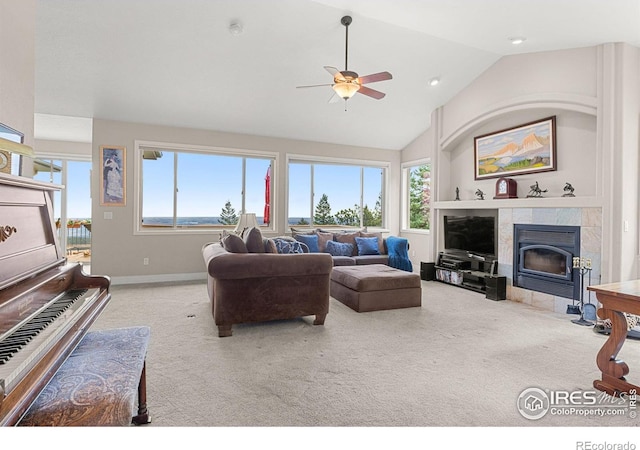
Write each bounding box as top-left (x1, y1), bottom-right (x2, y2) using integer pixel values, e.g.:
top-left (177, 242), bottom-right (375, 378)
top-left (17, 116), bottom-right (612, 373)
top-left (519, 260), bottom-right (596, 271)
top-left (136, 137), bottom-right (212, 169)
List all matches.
top-left (513, 224), bottom-right (580, 299)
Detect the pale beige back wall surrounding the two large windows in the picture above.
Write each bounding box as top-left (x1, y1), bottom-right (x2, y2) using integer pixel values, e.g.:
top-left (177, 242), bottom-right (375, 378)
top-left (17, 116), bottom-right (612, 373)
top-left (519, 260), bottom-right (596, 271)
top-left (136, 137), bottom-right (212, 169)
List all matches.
top-left (91, 119), bottom-right (400, 283)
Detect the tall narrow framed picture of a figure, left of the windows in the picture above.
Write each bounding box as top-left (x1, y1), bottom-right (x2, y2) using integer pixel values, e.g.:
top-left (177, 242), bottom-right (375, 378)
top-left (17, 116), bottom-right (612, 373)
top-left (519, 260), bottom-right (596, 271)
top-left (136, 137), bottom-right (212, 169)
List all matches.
top-left (100, 146), bottom-right (127, 206)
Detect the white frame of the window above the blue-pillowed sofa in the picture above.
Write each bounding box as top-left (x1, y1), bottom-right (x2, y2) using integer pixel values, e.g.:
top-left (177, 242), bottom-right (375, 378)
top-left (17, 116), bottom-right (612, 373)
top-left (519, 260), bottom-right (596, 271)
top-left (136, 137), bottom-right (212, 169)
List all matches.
top-left (284, 154), bottom-right (391, 231)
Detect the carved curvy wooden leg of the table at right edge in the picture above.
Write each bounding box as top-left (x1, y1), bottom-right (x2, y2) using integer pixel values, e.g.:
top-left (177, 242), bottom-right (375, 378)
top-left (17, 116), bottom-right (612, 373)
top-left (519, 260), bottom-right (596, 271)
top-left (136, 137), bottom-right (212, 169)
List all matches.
top-left (593, 308), bottom-right (638, 396)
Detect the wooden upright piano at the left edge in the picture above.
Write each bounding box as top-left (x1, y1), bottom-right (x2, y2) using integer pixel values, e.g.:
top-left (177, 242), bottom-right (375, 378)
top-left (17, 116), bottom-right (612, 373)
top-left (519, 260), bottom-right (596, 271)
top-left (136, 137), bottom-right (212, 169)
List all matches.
top-left (0, 174), bottom-right (111, 426)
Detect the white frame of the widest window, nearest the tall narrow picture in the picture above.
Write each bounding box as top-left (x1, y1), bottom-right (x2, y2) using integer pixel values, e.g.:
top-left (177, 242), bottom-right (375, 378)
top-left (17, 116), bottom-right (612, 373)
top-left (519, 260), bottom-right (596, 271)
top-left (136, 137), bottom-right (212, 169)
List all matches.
top-left (133, 140), bottom-right (279, 235)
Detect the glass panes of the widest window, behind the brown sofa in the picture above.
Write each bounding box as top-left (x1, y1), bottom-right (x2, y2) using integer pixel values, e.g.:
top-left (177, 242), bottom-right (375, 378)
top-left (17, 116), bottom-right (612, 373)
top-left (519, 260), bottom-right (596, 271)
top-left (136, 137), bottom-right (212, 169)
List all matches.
top-left (136, 143), bottom-right (275, 231)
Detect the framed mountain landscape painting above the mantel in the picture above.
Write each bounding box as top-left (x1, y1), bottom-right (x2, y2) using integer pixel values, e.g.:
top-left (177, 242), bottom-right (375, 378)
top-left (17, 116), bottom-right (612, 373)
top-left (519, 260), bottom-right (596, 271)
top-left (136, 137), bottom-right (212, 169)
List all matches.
top-left (474, 116), bottom-right (556, 180)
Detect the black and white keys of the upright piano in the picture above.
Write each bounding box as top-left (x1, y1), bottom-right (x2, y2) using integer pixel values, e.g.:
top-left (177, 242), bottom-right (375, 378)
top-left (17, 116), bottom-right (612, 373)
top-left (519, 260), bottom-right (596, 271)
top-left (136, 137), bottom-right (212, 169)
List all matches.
top-left (0, 289), bottom-right (87, 365)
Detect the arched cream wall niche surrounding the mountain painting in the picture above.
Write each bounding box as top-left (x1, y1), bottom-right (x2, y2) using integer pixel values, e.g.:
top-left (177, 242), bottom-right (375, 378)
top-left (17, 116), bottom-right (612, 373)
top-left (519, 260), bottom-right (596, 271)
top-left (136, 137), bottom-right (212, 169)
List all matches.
top-left (438, 94), bottom-right (599, 201)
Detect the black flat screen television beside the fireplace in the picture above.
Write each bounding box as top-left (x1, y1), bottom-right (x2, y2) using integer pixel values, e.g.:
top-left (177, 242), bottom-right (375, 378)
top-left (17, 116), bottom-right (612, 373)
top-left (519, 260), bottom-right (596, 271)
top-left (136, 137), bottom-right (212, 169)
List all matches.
top-left (444, 216), bottom-right (497, 256)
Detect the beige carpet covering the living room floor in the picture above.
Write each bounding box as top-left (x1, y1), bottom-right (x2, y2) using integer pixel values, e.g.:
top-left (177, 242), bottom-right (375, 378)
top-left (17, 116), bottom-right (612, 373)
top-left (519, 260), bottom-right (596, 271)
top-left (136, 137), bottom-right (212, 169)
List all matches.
top-left (93, 281), bottom-right (640, 427)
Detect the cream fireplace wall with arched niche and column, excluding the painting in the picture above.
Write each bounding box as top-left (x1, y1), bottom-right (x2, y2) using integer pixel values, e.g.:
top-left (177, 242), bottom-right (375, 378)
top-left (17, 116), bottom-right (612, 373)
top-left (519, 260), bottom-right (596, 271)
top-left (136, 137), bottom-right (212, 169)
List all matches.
top-left (402, 44), bottom-right (640, 282)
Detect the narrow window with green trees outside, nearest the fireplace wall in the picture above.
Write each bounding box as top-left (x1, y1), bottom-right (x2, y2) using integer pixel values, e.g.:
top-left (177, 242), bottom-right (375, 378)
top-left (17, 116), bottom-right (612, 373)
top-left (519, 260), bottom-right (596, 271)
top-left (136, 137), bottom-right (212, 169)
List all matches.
top-left (402, 160), bottom-right (431, 230)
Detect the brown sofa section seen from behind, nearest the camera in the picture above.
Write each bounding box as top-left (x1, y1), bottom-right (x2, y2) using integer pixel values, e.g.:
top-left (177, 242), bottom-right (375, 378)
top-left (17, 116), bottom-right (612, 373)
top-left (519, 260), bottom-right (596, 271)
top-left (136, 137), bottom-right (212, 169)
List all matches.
top-left (202, 241), bottom-right (333, 337)
